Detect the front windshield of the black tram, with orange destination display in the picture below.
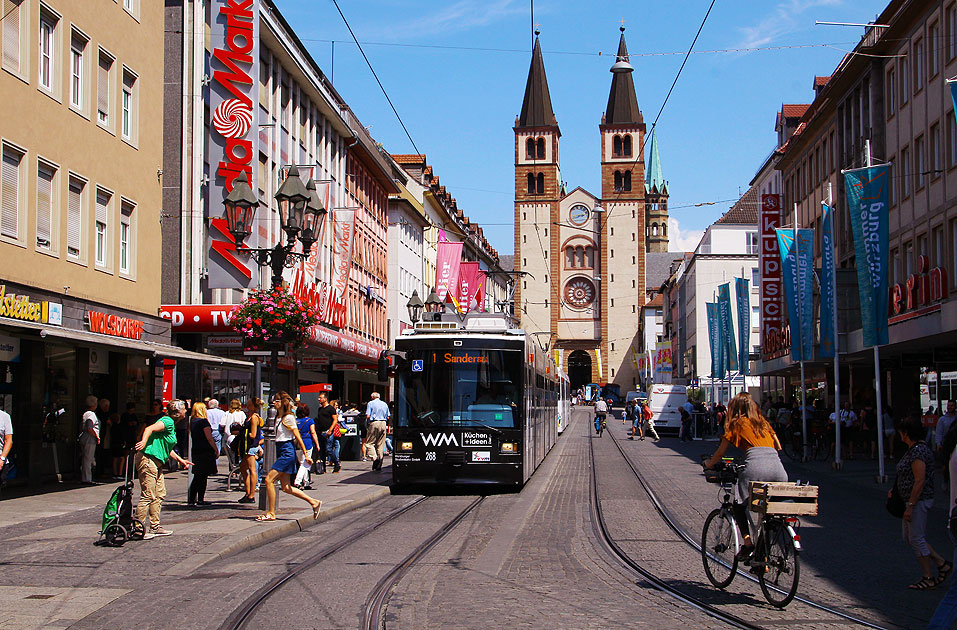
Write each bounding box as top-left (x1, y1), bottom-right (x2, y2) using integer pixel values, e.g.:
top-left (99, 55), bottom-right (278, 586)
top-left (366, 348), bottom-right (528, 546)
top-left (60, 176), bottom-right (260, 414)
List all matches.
top-left (397, 348), bottom-right (524, 428)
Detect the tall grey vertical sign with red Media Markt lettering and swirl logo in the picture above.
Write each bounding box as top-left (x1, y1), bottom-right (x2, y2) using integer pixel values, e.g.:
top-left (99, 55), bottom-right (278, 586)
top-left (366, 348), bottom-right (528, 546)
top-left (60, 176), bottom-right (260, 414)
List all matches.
top-left (205, 0), bottom-right (258, 289)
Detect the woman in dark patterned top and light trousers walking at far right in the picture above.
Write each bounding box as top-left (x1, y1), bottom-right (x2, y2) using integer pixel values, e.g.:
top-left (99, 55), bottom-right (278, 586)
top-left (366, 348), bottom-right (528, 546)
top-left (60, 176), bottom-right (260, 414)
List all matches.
top-left (887, 416), bottom-right (954, 591)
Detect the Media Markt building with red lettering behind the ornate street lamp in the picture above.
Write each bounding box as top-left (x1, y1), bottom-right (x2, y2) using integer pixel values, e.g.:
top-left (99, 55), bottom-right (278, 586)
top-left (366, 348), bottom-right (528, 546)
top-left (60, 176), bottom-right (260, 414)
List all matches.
top-left (162, 0), bottom-right (401, 401)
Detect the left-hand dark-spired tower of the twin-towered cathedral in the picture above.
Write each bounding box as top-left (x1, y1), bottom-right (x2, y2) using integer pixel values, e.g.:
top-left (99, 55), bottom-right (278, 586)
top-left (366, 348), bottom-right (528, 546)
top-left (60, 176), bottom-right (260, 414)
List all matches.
top-left (514, 31), bottom-right (563, 343)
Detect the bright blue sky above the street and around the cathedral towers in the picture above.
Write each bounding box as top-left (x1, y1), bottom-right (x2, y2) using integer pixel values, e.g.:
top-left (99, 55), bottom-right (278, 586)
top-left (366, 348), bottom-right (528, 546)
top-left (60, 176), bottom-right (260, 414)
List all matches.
top-left (276, 0), bottom-right (887, 254)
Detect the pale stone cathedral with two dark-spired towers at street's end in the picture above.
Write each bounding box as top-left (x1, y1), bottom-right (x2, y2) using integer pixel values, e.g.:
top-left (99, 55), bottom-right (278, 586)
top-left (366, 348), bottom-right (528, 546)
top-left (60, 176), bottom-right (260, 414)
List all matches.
top-left (514, 28), bottom-right (668, 394)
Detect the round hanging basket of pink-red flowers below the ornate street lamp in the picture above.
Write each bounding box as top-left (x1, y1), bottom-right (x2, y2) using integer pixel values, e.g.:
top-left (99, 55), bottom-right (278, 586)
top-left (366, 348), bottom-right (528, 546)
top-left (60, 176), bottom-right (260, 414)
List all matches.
top-left (229, 290), bottom-right (319, 349)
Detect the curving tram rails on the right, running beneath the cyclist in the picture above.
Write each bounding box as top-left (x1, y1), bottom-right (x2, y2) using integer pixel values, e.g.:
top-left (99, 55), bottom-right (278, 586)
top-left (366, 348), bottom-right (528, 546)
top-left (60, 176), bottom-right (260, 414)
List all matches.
top-left (591, 424), bottom-right (887, 630)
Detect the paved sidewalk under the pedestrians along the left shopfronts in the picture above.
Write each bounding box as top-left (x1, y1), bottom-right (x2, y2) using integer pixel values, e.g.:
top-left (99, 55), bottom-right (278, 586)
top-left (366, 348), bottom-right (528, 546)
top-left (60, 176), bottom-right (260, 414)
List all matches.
top-left (0, 457), bottom-right (392, 576)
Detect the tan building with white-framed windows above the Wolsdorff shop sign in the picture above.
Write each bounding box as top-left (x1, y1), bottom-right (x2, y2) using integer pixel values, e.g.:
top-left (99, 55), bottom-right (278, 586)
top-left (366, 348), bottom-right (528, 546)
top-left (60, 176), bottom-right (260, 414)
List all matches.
top-left (0, 0), bottom-right (176, 482)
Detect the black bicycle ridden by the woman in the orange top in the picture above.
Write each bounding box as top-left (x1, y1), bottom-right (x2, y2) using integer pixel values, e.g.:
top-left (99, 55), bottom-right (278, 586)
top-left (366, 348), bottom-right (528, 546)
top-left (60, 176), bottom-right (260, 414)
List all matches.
top-left (701, 458), bottom-right (801, 608)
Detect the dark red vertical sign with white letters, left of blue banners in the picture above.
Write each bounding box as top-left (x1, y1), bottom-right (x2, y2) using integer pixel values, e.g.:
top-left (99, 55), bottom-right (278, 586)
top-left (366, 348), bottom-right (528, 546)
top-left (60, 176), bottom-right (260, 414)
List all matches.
top-left (758, 195), bottom-right (784, 358)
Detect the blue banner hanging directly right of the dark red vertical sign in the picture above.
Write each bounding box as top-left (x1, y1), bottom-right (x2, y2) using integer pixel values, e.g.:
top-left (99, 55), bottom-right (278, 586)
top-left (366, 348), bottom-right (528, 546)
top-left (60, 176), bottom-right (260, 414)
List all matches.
top-left (776, 228), bottom-right (814, 361)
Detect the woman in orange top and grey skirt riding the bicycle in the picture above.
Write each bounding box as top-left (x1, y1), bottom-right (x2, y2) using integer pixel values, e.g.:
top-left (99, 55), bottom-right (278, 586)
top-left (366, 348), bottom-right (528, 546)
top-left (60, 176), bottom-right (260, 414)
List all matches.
top-left (704, 392), bottom-right (788, 556)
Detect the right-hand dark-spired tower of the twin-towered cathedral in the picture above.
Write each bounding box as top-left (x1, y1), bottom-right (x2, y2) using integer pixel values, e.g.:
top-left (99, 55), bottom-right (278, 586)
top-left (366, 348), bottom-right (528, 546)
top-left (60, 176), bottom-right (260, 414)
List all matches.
top-left (599, 27), bottom-right (646, 391)
